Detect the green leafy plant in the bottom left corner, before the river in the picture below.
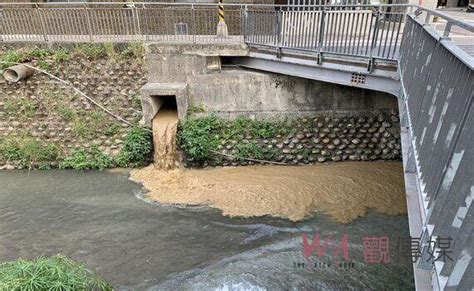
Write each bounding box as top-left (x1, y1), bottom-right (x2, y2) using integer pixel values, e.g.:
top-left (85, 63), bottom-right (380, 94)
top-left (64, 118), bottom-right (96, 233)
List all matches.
top-left (0, 255), bottom-right (112, 291)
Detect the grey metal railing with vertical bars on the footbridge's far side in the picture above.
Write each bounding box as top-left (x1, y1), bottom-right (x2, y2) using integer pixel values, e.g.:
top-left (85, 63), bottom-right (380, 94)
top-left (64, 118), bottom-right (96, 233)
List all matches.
top-left (245, 4), bottom-right (409, 60)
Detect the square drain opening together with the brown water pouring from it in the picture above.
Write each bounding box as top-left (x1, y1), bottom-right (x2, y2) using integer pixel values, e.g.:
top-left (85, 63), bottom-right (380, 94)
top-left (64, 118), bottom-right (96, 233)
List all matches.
top-left (151, 95), bottom-right (178, 170)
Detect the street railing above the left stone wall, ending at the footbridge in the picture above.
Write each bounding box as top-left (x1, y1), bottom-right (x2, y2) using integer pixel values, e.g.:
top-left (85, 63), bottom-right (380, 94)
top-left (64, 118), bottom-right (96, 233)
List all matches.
top-left (0, 2), bottom-right (245, 42)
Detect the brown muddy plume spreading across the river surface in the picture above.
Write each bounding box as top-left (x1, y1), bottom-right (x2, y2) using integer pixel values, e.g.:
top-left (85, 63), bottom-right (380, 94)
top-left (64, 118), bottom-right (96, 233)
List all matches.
top-left (131, 162), bottom-right (406, 223)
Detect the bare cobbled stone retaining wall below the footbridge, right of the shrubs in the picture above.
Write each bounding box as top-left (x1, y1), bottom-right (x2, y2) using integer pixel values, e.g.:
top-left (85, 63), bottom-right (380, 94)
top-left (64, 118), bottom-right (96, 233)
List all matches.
top-left (188, 110), bottom-right (401, 166)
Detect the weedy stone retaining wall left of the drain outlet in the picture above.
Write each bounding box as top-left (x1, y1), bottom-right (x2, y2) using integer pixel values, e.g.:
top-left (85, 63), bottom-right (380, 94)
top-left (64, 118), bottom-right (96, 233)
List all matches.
top-left (0, 45), bottom-right (146, 169)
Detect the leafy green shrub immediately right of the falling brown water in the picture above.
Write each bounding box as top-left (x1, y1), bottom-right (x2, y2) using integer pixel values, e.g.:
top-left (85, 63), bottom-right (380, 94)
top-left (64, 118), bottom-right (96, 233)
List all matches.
top-left (178, 115), bottom-right (222, 163)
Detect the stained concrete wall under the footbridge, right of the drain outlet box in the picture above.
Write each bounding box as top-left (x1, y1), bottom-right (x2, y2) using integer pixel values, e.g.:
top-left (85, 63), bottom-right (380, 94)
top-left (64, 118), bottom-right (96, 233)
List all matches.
top-left (188, 69), bottom-right (397, 117)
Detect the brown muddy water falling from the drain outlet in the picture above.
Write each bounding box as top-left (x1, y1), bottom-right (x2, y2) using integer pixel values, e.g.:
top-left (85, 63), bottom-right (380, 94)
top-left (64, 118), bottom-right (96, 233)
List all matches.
top-left (153, 109), bottom-right (178, 170)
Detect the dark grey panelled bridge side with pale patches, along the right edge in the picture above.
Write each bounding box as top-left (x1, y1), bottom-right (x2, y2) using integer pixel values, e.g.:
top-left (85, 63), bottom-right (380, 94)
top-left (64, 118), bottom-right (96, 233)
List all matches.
top-left (399, 9), bottom-right (474, 290)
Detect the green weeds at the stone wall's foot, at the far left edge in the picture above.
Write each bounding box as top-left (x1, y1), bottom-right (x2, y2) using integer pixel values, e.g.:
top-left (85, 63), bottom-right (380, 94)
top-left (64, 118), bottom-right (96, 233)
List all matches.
top-left (0, 135), bottom-right (59, 169)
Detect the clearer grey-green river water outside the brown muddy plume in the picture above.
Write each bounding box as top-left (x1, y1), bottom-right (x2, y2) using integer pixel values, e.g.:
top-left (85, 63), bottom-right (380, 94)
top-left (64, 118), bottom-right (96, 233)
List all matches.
top-left (0, 170), bottom-right (414, 290)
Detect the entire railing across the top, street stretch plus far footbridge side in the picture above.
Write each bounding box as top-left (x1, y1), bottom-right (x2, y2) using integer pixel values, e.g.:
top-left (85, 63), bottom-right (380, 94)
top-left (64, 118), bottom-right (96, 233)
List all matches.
top-left (0, 0), bottom-right (472, 63)
